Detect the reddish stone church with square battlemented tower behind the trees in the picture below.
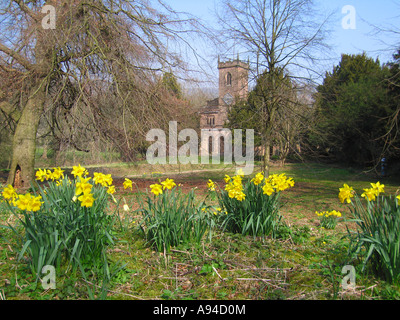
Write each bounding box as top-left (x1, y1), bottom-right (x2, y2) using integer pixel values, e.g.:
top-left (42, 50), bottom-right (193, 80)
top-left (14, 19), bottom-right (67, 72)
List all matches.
top-left (200, 57), bottom-right (249, 155)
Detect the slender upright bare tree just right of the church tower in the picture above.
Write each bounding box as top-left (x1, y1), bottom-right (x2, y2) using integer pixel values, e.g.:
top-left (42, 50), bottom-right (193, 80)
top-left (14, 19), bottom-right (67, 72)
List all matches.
top-left (219, 0), bottom-right (327, 172)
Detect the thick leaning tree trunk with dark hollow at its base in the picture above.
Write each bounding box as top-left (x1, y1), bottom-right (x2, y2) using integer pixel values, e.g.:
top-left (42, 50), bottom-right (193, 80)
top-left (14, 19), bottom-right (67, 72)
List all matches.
top-left (7, 83), bottom-right (46, 189)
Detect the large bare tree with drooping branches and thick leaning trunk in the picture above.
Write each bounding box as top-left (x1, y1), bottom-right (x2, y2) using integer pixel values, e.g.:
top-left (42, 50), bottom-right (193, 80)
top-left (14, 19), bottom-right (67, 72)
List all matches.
top-left (0, 0), bottom-right (211, 187)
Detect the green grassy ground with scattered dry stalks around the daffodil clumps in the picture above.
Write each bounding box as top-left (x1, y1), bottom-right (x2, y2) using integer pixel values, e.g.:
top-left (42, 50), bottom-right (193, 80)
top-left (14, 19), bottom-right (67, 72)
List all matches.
top-left (0, 164), bottom-right (400, 300)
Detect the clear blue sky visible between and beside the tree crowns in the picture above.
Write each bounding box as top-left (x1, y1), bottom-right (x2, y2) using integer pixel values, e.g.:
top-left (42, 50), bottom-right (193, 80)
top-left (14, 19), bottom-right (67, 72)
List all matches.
top-left (165, 0), bottom-right (400, 84)
